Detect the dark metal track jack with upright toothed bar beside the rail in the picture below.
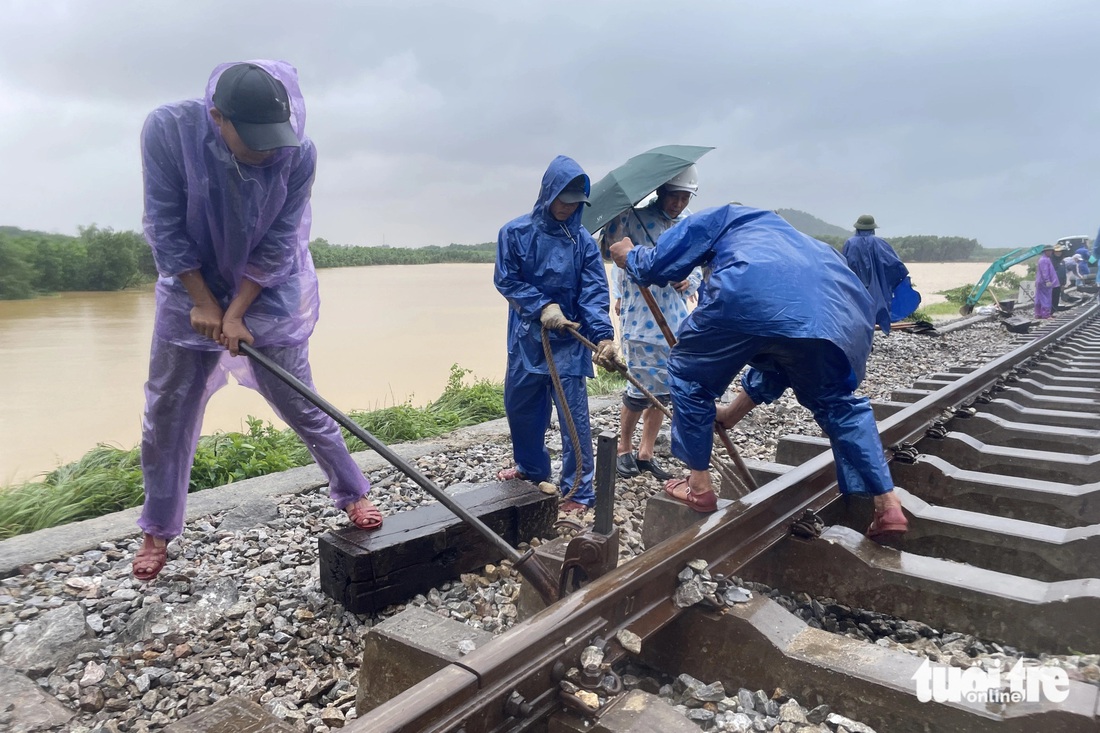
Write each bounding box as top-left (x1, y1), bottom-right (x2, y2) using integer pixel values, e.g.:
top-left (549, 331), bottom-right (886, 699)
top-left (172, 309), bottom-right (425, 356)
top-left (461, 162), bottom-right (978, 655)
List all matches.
top-left (558, 430), bottom-right (619, 597)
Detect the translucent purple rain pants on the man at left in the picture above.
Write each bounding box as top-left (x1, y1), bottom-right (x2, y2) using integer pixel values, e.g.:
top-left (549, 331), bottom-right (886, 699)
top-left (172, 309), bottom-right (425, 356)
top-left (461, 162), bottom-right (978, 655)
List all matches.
top-left (138, 336), bottom-right (371, 539)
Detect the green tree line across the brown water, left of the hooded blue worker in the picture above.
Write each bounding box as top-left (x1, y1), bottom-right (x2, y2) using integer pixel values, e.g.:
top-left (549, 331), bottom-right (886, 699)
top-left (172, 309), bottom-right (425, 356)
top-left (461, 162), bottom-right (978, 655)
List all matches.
top-left (0, 225), bottom-right (496, 300)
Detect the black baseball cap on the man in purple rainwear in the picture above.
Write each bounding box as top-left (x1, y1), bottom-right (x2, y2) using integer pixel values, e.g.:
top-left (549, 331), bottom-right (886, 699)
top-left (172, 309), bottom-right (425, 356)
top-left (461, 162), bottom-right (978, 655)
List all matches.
top-left (213, 64), bottom-right (301, 151)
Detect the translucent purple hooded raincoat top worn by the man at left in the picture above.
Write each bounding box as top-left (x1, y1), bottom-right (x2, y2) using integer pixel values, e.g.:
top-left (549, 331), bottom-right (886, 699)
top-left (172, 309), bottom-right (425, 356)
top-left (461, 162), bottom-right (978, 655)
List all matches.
top-left (142, 61), bottom-right (319, 351)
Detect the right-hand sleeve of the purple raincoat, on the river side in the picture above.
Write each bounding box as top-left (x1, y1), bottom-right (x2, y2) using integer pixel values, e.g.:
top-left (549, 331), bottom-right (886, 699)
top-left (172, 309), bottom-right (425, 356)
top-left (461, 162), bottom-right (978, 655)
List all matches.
top-left (243, 140), bottom-right (317, 287)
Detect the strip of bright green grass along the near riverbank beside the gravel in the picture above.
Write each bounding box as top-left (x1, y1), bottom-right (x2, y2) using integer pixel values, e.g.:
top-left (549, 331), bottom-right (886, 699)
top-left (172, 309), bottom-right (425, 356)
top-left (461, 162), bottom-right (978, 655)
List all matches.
top-left (0, 364), bottom-right (626, 539)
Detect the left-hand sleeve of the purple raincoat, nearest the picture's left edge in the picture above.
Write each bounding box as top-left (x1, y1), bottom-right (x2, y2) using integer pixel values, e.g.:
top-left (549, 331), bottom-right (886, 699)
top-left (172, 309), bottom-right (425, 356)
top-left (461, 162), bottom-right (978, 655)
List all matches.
top-left (141, 108), bottom-right (201, 277)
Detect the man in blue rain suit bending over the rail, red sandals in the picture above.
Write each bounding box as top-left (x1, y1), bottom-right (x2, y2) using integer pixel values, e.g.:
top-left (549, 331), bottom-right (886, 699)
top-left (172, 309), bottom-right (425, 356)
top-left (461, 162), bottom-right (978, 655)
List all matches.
top-left (611, 206), bottom-right (909, 541)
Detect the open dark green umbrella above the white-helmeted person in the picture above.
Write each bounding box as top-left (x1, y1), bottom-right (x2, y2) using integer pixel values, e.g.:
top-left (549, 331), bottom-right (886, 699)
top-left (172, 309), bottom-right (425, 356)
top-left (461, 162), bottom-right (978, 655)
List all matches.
top-left (581, 145), bottom-right (714, 232)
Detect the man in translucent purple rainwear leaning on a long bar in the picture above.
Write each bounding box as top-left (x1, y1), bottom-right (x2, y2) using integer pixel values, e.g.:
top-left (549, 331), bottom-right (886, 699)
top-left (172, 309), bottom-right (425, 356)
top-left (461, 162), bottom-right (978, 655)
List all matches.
top-left (133, 61), bottom-right (382, 580)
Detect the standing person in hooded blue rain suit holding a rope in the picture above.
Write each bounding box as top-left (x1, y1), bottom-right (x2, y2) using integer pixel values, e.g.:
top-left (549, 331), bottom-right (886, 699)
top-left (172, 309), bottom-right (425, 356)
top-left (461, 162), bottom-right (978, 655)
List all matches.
top-left (493, 155), bottom-right (617, 512)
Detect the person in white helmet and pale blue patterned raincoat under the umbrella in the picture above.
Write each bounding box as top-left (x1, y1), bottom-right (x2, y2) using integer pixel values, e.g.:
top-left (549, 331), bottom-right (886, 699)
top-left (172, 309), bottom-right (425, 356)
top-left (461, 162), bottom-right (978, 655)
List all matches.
top-left (604, 165), bottom-right (703, 481)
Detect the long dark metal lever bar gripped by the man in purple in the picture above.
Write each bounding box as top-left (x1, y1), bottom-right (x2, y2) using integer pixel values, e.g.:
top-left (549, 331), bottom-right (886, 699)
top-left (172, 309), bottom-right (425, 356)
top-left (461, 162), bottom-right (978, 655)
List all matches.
top-left (240, 341), bottom-right (559, 605)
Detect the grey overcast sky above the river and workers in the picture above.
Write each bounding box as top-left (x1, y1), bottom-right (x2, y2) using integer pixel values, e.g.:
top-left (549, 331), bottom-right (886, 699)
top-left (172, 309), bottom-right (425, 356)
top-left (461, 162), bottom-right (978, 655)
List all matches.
top-left (0, 0), bottom-right (1100, 247)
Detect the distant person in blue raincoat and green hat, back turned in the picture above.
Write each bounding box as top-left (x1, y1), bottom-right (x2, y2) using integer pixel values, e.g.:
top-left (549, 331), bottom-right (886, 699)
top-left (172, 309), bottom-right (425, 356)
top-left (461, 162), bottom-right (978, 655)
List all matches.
top-left (842, 214), bottom-right (921, 333)
